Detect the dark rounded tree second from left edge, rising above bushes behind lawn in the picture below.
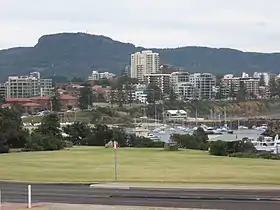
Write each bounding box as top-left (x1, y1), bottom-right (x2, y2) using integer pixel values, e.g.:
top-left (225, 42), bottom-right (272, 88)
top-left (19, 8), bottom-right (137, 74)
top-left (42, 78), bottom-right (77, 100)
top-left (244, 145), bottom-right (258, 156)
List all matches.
top-left (35, 114), bottom-right (62, 138)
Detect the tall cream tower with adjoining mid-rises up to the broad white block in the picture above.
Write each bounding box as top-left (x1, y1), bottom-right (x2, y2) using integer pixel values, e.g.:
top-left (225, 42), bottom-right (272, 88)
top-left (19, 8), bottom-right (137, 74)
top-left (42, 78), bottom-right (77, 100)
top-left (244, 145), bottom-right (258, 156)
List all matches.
top-left (130, 50), bottom-right (217, 99)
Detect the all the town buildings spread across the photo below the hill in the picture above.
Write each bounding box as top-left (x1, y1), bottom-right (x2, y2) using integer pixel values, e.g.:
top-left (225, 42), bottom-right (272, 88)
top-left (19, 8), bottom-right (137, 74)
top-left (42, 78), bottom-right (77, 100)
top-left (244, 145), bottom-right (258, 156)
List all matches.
top-left (0, 50), bottom-right (278, 113)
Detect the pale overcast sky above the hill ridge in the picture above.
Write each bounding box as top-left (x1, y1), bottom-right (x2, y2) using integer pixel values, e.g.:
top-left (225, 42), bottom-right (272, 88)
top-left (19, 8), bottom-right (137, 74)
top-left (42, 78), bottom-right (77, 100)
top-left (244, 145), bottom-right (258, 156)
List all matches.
top-left (0, 0), bottom-right (280, 52)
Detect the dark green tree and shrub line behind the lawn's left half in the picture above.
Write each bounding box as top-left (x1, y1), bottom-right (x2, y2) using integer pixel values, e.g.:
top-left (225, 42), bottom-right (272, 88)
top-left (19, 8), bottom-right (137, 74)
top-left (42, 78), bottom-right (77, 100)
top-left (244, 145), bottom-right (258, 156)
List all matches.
top-left (0, 107), bottom-right (163, 153)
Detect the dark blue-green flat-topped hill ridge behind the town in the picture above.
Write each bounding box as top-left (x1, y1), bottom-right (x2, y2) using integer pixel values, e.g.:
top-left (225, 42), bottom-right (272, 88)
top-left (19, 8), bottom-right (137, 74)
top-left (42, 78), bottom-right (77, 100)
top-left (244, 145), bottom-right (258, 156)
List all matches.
top-left (0, 33), bottom-right (280, 80)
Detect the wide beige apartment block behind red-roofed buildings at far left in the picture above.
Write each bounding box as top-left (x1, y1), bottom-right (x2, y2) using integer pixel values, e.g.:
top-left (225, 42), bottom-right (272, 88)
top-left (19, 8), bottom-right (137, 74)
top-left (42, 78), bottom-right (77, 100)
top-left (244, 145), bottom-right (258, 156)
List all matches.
top-left (6, 73), bottom-right (52, 98)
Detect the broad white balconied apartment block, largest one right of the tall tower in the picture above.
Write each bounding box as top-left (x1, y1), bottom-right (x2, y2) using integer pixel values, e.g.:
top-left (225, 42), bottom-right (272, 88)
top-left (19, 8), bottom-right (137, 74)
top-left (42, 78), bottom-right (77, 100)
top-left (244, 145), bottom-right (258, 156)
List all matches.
top-left (189, 73), bottom-right (216, 99)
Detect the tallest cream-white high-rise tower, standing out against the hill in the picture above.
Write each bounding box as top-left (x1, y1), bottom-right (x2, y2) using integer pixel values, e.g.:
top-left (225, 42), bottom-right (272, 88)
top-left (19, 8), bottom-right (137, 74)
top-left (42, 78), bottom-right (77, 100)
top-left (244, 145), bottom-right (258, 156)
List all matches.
top-left (130, 50), bottom-right (159, 81)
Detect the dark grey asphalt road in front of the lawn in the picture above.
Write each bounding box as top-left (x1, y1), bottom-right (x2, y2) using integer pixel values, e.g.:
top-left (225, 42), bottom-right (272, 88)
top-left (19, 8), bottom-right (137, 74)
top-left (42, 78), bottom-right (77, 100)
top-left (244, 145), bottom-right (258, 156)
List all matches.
top-left (0, 182), bottom-right (280, 210)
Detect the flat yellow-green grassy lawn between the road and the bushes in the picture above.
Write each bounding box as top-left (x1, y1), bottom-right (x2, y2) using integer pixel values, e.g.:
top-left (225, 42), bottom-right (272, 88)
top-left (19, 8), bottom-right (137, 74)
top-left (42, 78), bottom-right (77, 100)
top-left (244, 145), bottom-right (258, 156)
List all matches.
top-left (0, 147), bottom-right (280, 184)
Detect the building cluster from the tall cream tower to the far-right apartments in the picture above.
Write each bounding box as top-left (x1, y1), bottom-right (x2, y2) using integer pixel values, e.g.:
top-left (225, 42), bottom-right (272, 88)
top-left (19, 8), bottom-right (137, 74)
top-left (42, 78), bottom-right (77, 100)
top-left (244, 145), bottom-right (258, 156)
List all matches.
top-left (130, 50), bottom-right (271, 100)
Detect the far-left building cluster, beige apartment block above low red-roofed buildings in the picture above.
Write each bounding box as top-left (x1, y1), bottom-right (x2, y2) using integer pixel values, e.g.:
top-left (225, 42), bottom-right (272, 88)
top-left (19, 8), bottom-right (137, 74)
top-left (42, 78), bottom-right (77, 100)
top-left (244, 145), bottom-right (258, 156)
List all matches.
top-left (0, 72), bottom-right (78, 112)
